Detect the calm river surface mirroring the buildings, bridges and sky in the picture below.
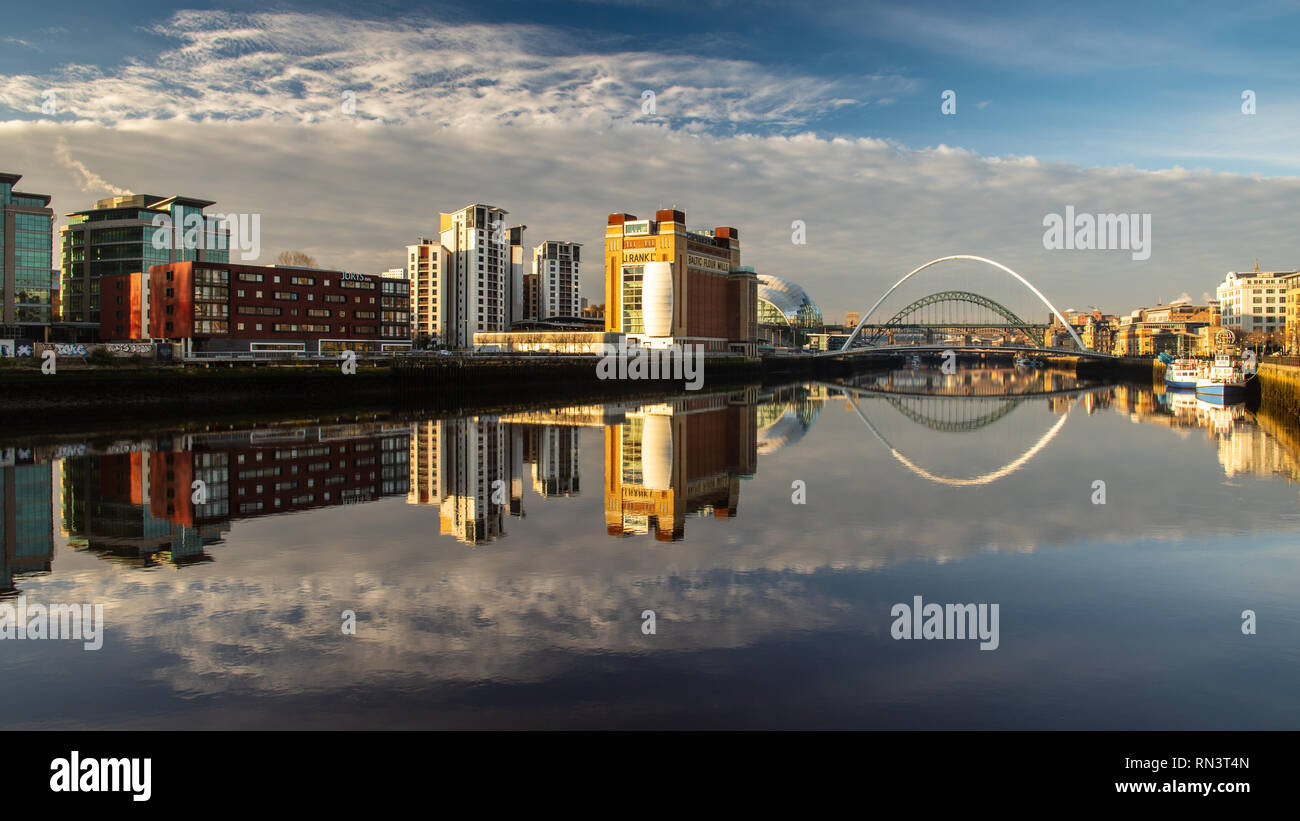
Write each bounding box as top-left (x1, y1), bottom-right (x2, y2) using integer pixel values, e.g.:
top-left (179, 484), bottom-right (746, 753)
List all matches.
top-left (0, 369), bottom-right (1300, 729)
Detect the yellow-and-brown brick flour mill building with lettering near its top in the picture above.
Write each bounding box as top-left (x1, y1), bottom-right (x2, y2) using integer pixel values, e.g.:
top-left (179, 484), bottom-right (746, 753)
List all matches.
top-left (605, 209), bottom-right (758, 356)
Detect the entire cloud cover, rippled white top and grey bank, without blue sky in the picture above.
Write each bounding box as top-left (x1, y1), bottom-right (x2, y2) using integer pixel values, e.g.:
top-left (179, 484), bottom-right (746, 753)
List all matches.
top-left (0, 12), bottom-right (1300, 317)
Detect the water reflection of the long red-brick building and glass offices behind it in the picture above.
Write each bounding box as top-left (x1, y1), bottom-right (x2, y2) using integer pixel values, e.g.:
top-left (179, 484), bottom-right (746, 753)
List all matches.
top-left (62, 425), bottom-right (411, 566)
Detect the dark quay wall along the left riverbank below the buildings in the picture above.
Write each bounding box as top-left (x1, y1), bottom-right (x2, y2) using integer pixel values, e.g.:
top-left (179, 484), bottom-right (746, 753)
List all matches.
top-left (0, 356), bottom-right (893, 433)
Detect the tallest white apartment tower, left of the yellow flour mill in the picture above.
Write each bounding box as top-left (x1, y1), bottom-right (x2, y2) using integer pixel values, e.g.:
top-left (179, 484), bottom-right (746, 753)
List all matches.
top-left (438, 203), bottom-right (514, 347)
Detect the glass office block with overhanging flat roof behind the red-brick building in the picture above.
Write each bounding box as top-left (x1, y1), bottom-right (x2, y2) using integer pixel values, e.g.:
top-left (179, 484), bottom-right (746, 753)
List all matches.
top-left (60, 194), bottom-right (230, 327)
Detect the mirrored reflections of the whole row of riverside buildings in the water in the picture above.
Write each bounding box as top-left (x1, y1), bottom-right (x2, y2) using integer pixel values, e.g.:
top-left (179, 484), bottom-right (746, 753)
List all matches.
top-left (12, 370), bottom-right (1300, 584)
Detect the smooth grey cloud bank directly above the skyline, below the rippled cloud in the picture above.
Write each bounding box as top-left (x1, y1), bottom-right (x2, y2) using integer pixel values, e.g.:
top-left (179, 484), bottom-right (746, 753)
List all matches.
top-left (10, 115), bottom-right (1300, 317)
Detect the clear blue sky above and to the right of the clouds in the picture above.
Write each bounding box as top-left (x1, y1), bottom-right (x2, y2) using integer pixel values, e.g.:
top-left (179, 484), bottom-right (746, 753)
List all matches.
top-left (0, 0), bottom-right (1300, 174)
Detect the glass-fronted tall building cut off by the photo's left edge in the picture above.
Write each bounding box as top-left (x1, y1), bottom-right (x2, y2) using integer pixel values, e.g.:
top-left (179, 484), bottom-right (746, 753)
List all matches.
top-left (0, 173), bottom-right (57, 339)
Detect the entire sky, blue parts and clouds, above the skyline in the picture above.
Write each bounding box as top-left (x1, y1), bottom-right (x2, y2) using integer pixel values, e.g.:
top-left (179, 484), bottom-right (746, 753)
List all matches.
top-left (0, 0), bottom-right (1300, 321)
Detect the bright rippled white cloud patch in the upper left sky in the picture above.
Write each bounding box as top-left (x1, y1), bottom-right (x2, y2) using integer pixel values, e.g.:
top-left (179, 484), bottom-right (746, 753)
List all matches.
top-left (0, 12), bottom-right (917, 131)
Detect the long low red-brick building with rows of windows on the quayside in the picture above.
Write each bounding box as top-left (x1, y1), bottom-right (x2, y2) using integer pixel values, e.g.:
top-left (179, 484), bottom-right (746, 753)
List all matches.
top-left (143, 262), bottom-right (411, 355)
